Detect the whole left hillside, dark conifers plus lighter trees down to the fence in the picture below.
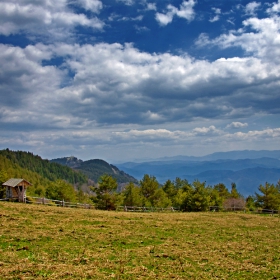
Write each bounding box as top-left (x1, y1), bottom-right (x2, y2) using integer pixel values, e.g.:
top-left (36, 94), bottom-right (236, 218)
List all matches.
top-left (0, 149), bottom-right (92, 200)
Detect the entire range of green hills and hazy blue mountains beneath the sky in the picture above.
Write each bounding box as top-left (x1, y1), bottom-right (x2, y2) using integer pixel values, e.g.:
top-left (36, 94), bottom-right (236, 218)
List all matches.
top-left (0, 149), bottom-right (280, 196)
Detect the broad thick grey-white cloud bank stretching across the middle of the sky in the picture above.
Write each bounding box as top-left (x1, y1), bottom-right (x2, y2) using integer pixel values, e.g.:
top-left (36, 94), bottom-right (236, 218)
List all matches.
top-left (0, 39), bottom-right (280, 130)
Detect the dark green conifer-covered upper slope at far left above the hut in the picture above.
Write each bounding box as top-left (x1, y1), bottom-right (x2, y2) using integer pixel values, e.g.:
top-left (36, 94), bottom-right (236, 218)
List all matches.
top-left (0, 149), bottom-right (88, 185)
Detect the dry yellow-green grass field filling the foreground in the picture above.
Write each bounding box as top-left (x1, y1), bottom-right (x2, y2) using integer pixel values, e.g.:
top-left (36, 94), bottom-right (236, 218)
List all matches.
top-left (0, 202), bottom-right (280, 280)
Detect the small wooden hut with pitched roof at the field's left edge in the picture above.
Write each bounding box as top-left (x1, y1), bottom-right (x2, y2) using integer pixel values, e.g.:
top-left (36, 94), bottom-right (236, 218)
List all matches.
top-left (2, 178), bottom-right (31, 202)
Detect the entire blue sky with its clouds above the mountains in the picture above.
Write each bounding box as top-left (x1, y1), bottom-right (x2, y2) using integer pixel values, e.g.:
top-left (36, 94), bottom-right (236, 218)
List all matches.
top-left (0, 0), bottom-right (280, 163)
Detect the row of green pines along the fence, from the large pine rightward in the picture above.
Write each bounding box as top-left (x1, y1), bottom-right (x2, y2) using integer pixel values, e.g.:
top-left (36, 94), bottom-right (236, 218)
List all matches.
top-left (91, 174), bottom-right (280, 211)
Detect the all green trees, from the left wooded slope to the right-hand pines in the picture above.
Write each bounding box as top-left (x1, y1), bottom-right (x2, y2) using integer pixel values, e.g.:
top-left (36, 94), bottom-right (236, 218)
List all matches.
top-left (0, 149), bottom-right (280, 211)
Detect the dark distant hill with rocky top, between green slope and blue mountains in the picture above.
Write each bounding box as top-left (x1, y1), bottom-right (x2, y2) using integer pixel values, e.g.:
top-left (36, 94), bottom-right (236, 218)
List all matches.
top-left (51, 156), bottom-right (138, 184)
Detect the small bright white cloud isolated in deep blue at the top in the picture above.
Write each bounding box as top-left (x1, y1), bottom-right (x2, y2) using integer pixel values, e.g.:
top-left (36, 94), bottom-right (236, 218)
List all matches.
top-left (156, 0), bottom-right (196, 26)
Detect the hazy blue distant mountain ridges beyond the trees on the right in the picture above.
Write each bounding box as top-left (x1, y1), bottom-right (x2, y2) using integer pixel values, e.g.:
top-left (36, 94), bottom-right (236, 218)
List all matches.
top-left (114, 150), bottom-right (280, 196)
